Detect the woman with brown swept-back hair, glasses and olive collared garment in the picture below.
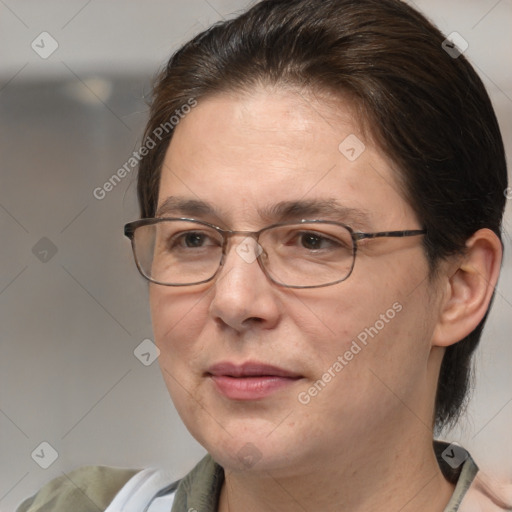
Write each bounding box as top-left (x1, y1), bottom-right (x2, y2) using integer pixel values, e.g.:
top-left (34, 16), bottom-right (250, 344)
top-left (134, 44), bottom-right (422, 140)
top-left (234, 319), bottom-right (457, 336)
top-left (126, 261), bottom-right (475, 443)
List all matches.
top-left (19, 0), bottom-right (511, 512)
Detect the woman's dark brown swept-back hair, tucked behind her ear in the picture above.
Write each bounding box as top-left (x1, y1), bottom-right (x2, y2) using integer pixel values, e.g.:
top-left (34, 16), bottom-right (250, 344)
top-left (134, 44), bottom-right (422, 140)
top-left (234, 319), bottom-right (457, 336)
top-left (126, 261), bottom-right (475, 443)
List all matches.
top-left (138, 0), bottom-right (507, 428)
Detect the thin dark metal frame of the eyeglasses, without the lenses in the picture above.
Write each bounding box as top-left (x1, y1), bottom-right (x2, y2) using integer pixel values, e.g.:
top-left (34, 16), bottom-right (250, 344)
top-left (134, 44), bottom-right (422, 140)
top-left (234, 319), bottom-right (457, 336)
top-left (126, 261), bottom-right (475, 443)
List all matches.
top-left (124, 217), bottom-right (427, 289)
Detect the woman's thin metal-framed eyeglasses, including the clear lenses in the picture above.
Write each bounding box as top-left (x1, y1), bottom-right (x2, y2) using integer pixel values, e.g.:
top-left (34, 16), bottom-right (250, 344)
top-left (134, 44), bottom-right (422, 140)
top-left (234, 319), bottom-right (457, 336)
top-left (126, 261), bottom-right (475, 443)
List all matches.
top-left (124, 218), bottom-right (426, 288)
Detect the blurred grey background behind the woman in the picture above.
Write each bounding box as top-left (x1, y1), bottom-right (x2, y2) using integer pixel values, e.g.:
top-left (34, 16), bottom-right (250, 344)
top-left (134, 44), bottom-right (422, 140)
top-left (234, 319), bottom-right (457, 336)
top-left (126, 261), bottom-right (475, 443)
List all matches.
top-left (0, 0), bottom-right (512, 511)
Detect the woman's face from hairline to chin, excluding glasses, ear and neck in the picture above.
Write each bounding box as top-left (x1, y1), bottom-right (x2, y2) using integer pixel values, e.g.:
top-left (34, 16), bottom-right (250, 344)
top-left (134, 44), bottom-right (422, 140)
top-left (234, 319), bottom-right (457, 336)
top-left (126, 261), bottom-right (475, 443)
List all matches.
top-left (150, 89), bottom-right (437, 473)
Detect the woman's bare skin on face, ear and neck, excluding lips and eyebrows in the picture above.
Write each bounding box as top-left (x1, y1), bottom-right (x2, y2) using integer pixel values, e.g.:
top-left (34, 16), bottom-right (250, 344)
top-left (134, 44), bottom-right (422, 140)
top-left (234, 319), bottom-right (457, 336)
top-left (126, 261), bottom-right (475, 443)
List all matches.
top-left (150, 87), bottom-right (501, 512)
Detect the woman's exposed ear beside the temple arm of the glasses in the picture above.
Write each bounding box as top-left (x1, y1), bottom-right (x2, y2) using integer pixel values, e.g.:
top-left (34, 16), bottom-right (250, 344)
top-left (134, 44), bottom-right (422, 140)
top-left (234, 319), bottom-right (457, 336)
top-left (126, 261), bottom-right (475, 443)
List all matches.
top-left (432, 229), bottom-right (503, 347)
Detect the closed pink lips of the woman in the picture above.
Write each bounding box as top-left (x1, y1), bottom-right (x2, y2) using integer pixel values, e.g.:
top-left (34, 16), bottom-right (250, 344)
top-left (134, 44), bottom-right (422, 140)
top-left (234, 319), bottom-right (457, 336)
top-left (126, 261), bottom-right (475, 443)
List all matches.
top-left (206, 361), bottom-right (302, 400)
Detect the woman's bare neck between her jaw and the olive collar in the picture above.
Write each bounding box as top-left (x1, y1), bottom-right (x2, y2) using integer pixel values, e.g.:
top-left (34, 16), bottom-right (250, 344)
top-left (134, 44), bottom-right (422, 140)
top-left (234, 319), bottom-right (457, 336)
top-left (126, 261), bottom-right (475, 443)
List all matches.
top-left (218, 432), bottom-right (454, 512)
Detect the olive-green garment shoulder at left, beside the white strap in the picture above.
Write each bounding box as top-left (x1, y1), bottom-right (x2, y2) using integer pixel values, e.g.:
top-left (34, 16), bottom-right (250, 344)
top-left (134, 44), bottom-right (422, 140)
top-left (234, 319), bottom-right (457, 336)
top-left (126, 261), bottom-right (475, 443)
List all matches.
top-left (16, 466), bottom-right (139, 512)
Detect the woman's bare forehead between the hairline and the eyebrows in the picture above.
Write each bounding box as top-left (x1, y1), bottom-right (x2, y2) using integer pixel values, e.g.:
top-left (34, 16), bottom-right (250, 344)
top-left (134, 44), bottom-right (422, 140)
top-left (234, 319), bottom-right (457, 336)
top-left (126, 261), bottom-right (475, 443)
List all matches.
top-left (158, 89), bottom-right (414, 230)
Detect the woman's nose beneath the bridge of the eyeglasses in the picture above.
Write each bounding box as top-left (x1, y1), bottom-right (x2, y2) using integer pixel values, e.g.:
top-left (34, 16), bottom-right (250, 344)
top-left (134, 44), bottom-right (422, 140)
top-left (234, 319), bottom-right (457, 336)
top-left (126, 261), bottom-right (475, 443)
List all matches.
top-left (210, 236), bottom-right (281, 332)
